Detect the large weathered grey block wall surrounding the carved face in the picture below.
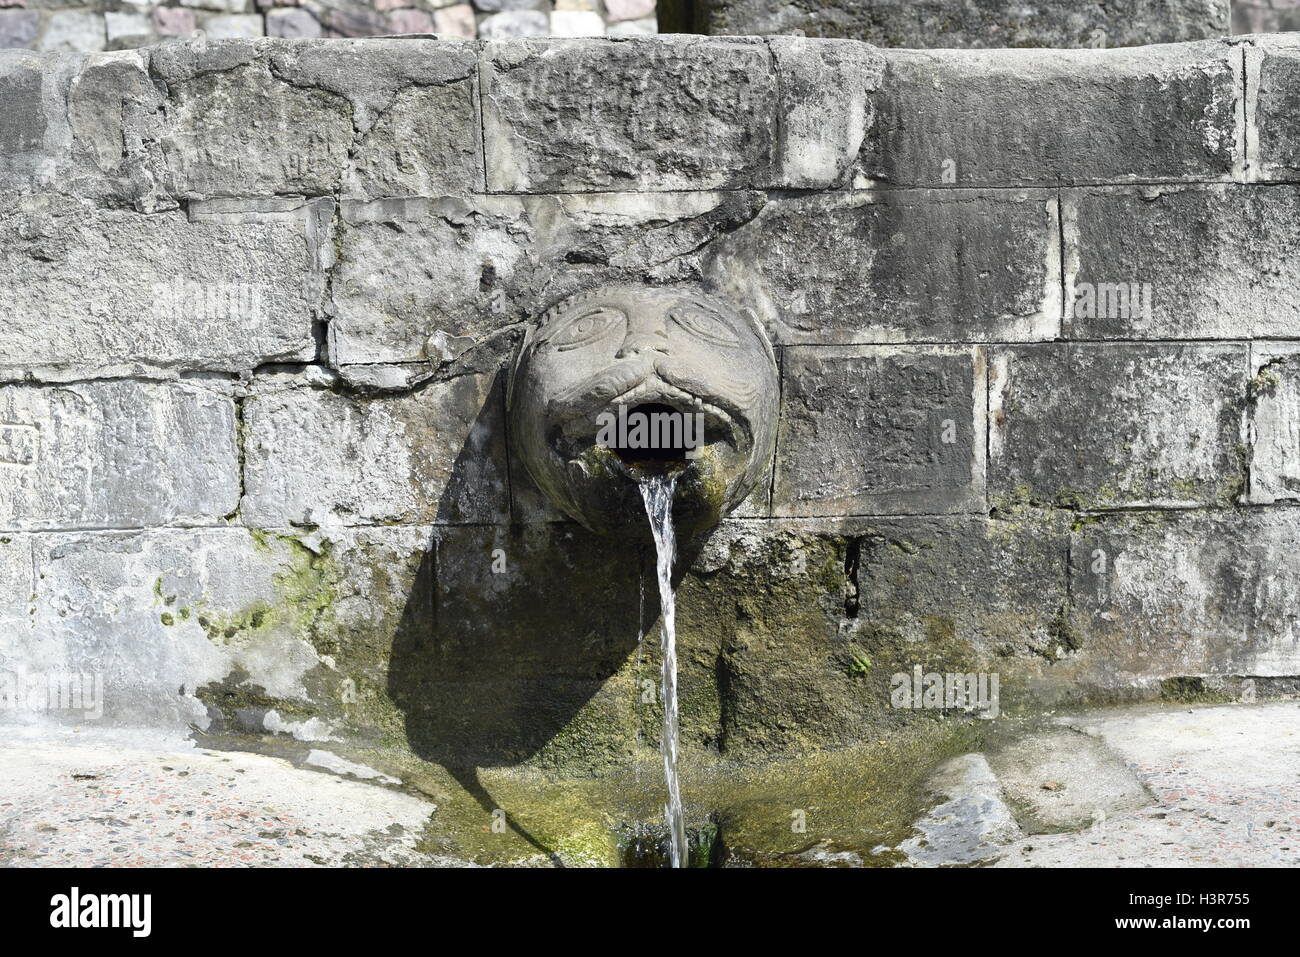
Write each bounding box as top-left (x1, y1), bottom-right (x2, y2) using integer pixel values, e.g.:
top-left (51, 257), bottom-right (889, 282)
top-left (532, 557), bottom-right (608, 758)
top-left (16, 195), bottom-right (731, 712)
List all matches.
top-left (0, 38), bottom-right (1300, 770)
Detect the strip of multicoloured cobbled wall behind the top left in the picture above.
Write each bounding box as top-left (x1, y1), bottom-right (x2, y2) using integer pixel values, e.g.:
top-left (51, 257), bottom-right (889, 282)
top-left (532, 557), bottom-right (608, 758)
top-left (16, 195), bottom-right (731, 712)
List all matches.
top-left (0, 0), bottom-right (658, 53)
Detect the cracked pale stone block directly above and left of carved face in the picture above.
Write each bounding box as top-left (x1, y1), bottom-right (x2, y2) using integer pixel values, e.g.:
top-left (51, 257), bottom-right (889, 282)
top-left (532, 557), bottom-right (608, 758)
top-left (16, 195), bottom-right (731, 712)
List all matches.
top-left (330, 192), bottom-right (762, 363)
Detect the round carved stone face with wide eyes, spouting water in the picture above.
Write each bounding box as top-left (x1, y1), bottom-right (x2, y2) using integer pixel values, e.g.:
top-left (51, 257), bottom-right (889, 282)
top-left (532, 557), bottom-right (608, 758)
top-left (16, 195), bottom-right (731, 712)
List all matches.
top-left (508, 286), bottom-right (777, 536)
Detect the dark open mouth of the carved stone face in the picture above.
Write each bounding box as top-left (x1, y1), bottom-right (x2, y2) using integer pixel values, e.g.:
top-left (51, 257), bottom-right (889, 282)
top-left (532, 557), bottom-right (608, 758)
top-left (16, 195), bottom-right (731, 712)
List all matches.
top-left (550, 377), bottom-right (750, 472)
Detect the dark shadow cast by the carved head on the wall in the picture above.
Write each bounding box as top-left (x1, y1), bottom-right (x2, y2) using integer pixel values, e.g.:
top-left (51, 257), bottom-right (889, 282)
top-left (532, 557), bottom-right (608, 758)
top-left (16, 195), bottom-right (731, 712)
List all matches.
top-left (387, 366), bottom-right (659, 780)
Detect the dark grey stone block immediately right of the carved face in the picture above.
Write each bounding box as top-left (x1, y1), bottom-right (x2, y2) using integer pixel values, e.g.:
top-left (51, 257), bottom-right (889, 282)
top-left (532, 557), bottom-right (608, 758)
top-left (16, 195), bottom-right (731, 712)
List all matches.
top-left (772, 346), bottom-right (985, 516)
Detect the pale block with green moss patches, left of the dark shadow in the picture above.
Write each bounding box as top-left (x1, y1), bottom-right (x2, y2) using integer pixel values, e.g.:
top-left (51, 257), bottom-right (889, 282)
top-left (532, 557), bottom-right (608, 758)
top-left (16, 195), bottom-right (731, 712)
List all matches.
top-left (0, 527), bottom-right (433, 740)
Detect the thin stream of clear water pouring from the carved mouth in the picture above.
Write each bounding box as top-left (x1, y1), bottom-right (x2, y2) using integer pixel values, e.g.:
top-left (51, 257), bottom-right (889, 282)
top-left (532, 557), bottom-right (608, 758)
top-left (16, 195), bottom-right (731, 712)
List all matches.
top-left (641, 475), bottom-right (686, 867)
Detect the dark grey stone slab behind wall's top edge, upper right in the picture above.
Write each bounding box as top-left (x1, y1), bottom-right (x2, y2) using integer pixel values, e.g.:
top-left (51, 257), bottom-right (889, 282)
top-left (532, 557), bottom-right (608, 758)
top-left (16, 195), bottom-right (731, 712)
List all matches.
top-left (697, 0), bottom-right (1230, 47)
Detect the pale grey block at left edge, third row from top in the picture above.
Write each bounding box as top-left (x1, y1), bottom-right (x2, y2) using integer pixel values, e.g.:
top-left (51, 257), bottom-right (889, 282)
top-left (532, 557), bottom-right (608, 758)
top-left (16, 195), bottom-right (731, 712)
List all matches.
top-left (0, 380), bottom-right (239, 529)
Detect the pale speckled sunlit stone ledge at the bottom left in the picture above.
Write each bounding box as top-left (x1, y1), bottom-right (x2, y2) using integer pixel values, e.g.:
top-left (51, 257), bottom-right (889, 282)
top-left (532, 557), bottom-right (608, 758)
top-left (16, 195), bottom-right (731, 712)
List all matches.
top-left (0, 731), bottom-right (442, 868)
